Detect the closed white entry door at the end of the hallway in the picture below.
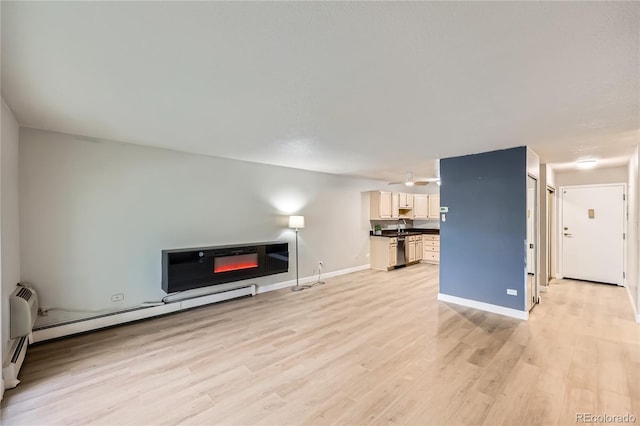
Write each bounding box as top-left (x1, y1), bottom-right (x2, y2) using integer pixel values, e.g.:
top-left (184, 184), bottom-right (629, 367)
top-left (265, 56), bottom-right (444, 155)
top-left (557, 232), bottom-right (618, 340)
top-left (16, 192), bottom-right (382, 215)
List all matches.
top-left (561, 185), bottom-right (624, 285)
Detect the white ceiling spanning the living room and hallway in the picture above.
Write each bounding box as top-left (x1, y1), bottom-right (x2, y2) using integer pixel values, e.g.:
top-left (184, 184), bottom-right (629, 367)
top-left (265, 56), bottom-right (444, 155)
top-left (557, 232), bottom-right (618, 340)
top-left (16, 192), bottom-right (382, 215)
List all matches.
top-left (1, 1), bottom-right (640, 180)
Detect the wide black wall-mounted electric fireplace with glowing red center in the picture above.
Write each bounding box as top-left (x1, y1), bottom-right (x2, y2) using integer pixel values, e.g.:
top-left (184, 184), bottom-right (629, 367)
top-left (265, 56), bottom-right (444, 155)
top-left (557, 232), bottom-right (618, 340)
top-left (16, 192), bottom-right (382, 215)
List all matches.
top-left (162, 241), bottom-right (289, 293)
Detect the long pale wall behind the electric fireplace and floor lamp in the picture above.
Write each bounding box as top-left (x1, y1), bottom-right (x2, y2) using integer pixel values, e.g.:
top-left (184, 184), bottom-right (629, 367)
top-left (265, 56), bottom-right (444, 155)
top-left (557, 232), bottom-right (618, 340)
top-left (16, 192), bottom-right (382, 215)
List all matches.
top-left (20, 129), bottom-right (384, 310)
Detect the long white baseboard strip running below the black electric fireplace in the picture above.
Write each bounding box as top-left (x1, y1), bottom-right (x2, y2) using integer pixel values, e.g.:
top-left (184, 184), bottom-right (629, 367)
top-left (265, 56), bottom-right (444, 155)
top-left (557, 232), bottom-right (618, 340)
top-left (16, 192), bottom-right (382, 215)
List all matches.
top-left (33, 265), bottom-right (370, 342)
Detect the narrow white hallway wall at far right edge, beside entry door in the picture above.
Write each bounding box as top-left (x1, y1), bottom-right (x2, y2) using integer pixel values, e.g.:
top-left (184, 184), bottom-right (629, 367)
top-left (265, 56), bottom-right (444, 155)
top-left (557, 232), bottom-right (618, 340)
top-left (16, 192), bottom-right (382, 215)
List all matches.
top-left (627, 147), bottom-right (640, 315)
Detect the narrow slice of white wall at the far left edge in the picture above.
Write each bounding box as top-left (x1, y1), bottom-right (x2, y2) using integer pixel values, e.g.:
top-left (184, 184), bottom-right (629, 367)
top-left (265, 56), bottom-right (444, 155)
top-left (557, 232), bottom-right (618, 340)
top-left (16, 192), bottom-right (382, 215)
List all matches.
top-left (0, 99), bottom-right (20, 376)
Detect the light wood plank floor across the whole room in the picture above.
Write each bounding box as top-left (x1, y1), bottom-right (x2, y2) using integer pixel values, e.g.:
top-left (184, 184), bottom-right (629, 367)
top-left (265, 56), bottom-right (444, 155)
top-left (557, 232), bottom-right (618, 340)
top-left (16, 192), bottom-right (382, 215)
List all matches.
top-left (0, 265), bottom-right (640, 425)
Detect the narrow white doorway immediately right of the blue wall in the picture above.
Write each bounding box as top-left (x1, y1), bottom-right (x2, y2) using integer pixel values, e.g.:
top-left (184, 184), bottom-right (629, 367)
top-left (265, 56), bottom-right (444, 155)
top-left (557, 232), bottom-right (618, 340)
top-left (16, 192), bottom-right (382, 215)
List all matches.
top-left (527, 176), bottom-right (538, 311)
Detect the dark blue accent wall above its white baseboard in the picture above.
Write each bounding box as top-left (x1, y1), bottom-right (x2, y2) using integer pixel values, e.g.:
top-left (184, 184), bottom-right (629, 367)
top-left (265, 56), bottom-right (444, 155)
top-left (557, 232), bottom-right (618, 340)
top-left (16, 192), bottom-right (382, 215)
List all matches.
top-left (440, 147), bottom-right (527, 311)
